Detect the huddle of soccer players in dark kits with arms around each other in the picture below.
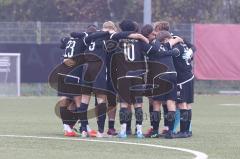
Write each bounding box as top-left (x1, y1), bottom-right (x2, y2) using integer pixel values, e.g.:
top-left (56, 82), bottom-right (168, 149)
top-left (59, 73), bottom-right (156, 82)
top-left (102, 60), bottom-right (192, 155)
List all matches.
top-left (55, 20), bottom-right (195, 139)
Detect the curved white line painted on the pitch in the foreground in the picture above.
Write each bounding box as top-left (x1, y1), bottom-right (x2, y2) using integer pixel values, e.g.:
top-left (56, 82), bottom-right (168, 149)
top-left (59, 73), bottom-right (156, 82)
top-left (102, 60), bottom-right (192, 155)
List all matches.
top-left (0, 135), bottom-right (208, 159)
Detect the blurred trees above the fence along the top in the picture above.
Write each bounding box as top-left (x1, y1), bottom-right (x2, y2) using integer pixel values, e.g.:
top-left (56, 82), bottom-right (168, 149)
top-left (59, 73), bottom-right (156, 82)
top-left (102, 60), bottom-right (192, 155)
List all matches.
top-left (0, 0), bottom-right (240, 23)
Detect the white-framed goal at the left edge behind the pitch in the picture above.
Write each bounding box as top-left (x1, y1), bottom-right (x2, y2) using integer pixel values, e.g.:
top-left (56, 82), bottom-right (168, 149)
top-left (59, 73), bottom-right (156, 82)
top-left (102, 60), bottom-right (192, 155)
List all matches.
top-left (0, 52), bottom-right (21, 96)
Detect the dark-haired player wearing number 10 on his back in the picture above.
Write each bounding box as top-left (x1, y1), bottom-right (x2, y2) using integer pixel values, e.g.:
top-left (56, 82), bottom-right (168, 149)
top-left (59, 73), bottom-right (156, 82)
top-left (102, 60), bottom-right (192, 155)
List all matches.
top-left (117, 20), bottom-right (180, 138)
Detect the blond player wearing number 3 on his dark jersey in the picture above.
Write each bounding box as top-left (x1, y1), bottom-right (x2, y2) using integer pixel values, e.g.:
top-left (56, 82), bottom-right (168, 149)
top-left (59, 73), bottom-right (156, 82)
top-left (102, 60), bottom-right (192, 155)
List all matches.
top-left (79, 21), bottom-right (149, 137)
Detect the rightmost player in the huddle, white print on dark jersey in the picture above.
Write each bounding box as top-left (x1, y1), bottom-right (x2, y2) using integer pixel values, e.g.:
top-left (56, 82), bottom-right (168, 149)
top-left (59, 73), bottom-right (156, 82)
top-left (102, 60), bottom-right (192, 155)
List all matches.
top-left (173, 36), bottom-right (194, 138)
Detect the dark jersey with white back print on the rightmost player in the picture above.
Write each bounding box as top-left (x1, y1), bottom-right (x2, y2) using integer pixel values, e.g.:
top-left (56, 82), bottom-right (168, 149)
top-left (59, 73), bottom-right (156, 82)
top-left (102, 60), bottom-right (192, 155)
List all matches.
top-left (173, 43), bottom-right (193, 83)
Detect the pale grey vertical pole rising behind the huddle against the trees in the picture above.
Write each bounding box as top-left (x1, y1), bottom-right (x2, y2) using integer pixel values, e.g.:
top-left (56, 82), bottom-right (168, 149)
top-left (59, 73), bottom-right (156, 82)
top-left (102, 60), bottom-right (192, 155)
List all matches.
top-left (143, 0), bottom-right (152, 24)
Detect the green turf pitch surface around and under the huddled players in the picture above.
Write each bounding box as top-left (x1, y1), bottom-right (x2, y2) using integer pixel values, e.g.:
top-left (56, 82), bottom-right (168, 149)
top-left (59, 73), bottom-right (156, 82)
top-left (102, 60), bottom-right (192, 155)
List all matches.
top-left (0, 95), bottom-right (240, 159)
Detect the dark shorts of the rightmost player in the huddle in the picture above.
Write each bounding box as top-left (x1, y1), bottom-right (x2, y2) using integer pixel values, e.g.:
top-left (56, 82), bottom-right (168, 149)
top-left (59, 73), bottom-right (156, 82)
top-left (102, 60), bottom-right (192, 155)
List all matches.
top-left (177, 80), bottom-right (194, 104)
